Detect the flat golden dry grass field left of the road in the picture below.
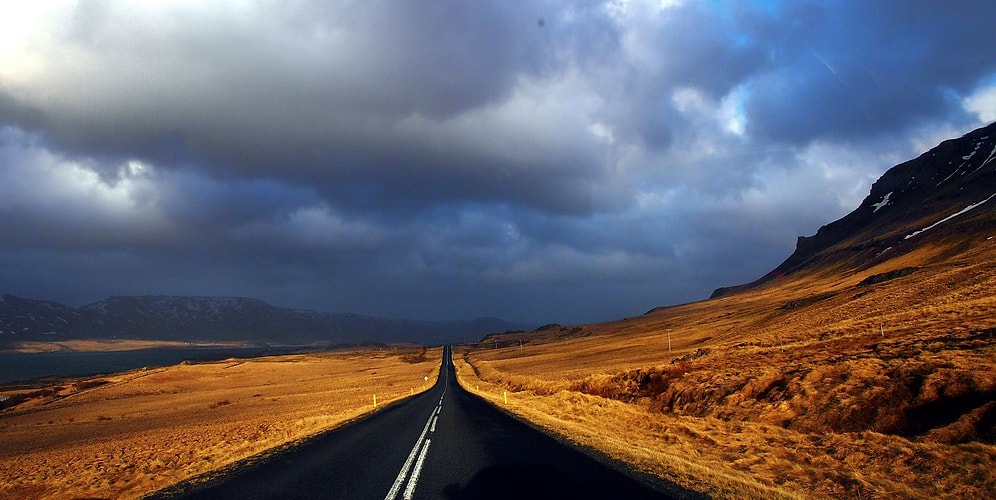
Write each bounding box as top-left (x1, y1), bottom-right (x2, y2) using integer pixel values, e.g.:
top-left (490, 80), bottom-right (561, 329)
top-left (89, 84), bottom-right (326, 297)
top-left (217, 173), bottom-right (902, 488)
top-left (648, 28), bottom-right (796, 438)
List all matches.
top-left (0, 349), bottom-right (442, 498)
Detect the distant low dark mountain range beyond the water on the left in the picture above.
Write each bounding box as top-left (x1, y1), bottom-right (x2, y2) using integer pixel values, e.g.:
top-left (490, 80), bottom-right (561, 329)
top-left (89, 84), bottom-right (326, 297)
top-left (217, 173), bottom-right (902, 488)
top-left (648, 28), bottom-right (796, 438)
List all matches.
top-left (0, 294), bottom-right (524, 344)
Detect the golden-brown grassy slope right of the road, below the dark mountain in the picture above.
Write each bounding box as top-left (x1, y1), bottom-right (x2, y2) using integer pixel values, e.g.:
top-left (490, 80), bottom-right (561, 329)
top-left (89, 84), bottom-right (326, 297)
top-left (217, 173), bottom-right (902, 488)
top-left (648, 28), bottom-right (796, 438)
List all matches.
top-left (455, 239), bottom-right (996, 498)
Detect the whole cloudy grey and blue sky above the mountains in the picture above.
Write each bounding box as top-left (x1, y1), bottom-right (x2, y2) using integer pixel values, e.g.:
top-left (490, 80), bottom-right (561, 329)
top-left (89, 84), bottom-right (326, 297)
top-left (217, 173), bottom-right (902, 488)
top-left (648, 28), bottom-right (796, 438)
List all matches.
top-left (0, 0), bottom-right (996, 324)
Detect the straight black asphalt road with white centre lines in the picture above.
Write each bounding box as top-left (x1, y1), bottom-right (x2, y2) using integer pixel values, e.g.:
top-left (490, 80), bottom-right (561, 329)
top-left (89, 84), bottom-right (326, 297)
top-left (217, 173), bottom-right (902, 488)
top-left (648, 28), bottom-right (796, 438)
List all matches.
top-left (167, 348), bottom-right (697, 500)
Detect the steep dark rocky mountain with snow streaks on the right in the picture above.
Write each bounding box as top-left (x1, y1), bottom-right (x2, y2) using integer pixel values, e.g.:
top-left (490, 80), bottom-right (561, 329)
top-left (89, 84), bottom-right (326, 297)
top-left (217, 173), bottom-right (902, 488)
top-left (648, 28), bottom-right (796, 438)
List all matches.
top-left (712, 123), bottom-right (996, 297)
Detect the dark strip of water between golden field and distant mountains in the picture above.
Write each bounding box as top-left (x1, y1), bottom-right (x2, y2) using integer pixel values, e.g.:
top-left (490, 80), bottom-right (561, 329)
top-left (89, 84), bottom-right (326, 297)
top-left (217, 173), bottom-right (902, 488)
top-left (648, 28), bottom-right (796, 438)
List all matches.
top-left (0, 347), bottom-right (300, 384)
